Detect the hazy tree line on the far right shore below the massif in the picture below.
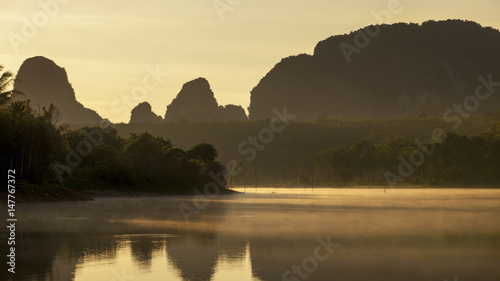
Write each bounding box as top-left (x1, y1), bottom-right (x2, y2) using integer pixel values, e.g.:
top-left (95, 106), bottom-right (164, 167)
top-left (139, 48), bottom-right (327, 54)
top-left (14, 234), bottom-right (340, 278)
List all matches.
top-left (311, 127), bottom-right (500, 186)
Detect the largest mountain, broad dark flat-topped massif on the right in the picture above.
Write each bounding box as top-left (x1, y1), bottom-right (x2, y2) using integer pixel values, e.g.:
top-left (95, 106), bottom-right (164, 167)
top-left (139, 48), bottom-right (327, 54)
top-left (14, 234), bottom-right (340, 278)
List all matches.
top-left (249, 20), bottom-right (500, 121)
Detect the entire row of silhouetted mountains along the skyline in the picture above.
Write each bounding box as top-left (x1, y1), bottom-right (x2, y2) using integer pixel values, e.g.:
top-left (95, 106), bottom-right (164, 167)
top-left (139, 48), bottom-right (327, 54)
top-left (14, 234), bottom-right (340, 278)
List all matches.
top-left (14, 20), bottom-right (500, 124)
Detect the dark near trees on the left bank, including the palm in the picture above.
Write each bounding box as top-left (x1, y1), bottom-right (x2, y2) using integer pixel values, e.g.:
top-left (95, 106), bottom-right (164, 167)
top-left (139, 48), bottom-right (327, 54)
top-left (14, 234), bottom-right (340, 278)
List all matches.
top-left (0, 73), bottom-right (229, 193)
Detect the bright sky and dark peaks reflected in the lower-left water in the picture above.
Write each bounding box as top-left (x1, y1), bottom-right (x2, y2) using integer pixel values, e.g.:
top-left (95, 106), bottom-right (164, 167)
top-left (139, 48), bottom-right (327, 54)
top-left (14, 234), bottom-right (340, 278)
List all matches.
top-left (4, 234), bottom-right (259, 281)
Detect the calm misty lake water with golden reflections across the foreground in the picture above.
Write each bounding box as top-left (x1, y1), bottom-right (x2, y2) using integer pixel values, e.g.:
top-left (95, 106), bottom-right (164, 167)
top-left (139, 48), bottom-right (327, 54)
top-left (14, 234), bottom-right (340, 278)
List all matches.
top-left (0, 188), bottom-right (500, 281)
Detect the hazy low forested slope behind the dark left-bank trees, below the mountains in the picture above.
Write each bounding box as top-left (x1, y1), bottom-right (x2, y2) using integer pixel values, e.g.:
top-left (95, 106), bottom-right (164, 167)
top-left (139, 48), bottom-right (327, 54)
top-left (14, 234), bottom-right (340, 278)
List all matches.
top-left (115, 111), bottom-right (500, 185)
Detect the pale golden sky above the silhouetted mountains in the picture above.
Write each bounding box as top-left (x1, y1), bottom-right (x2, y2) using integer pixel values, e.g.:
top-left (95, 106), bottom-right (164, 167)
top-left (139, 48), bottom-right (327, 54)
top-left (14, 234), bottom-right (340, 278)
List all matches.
top-left (0, 0), bottom-right (500, 122)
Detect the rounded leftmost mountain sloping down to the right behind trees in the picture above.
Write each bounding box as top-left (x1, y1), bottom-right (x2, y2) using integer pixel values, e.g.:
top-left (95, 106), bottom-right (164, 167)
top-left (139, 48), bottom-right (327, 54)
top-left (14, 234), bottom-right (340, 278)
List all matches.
top-left (14, 56), bottom-right (102, 124)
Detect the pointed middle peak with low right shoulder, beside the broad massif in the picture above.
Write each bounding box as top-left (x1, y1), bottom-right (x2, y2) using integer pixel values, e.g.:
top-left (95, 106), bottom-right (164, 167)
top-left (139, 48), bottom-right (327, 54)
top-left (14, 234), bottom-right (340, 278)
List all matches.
top-left (165, 77), bottom-right (247, 122)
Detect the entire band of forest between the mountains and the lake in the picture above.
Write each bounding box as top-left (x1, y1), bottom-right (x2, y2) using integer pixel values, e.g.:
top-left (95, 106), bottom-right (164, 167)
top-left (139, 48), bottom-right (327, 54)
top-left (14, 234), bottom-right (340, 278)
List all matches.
top-left (0, 86), bottom-right (500, 190)
